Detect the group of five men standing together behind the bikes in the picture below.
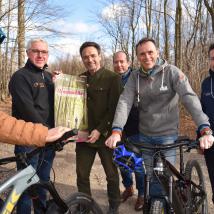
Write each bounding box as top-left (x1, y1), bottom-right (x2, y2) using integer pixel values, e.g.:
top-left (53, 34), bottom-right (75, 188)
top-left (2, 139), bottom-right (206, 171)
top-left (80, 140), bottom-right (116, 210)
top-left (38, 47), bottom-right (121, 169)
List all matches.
top-left (0, 33), bottom-right (214, 214)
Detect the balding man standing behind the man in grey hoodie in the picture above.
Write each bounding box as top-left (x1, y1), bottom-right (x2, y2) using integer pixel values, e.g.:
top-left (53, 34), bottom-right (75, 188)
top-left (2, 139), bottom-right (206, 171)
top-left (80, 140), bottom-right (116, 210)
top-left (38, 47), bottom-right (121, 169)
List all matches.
top-left (113, 51), bottom-right (144, 211)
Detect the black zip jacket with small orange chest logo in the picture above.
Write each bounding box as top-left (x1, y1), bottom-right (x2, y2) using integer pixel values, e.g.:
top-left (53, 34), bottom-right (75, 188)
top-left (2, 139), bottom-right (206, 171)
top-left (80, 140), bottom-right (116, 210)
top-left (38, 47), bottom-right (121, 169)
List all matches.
top-left (9, 60), bottom-right (54, 128)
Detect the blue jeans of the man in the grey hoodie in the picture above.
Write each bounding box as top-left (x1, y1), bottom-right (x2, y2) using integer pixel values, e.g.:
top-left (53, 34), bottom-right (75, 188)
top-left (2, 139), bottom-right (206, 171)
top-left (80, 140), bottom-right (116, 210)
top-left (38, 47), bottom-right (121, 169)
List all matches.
top-left (131, 134), bottom-right (178, 196)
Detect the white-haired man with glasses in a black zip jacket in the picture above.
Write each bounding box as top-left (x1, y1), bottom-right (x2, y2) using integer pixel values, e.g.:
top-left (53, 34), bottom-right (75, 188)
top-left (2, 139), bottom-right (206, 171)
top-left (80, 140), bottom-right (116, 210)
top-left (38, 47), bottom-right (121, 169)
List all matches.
top-left (9, 38), bottom-right (55, 214)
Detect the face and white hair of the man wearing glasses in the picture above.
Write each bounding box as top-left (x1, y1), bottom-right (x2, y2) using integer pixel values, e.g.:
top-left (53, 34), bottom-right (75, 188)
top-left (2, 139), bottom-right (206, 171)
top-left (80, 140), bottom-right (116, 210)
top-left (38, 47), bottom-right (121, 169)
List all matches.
top-left (27, 41), bottom-right (48, 68)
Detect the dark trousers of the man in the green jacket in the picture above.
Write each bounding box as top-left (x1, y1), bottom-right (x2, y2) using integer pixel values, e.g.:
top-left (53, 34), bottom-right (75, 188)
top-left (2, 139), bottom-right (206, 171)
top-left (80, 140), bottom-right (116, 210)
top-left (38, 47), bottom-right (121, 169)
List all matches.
top-left (76, 143), bottom-right (120, 207)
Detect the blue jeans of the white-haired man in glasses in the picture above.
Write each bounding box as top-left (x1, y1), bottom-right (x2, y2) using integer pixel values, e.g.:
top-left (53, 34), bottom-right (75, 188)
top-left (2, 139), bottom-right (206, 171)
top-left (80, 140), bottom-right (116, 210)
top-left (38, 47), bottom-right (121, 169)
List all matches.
top-left (15, 146), bottom-right (55, 214)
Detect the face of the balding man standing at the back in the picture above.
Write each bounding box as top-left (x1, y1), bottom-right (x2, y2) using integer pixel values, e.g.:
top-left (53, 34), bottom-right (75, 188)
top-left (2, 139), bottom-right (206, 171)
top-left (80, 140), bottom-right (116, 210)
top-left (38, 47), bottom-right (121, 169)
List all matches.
top-left (113, 52), bottom-right (129, 74)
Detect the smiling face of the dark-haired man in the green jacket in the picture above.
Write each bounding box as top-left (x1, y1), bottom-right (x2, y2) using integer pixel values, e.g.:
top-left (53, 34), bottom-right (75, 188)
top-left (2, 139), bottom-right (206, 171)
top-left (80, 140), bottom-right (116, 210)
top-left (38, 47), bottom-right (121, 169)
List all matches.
top-left (81, 46), bottom-right (101, 74)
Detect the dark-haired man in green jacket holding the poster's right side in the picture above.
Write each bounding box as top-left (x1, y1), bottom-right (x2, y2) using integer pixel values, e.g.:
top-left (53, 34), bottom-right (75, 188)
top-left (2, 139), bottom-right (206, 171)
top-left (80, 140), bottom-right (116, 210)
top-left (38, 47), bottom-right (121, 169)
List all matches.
top-left (76, 42), bottom-right (122, 214)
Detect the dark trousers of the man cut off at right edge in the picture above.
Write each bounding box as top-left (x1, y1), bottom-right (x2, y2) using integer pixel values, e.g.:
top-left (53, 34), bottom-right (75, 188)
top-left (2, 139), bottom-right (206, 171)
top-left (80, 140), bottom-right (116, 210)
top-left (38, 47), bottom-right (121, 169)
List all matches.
top-left (204, 146), bottom-right (214, 203)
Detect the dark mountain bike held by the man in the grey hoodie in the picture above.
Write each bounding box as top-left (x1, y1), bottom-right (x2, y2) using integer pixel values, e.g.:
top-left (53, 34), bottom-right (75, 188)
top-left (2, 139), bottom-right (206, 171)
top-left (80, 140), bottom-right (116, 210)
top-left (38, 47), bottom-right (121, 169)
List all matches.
top-left (115, 137), bottom-right (208, 214)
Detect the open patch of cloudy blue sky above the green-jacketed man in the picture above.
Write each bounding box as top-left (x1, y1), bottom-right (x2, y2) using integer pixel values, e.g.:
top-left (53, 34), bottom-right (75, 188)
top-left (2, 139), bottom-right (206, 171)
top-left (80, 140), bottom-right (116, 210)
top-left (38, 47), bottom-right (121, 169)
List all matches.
top-left (47, 0), bottom-right (106, 60)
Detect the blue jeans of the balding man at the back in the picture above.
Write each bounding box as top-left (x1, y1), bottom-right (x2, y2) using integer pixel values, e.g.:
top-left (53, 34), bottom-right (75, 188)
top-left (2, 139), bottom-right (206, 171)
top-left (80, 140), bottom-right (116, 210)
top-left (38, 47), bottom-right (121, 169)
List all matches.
top-left (120, 135), bottom-right (145, 196)
